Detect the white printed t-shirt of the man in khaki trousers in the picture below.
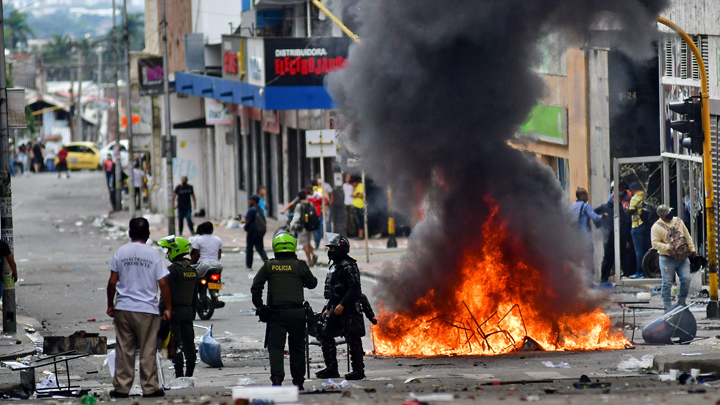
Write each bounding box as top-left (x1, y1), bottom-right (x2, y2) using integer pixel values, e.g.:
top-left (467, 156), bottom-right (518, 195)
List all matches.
top-left (110, 242), bottom-right (169, 314)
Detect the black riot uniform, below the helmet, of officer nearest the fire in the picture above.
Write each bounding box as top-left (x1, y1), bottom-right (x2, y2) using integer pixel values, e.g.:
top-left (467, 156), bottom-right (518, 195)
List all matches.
top-left (318, 255), bottom-right (365, 379)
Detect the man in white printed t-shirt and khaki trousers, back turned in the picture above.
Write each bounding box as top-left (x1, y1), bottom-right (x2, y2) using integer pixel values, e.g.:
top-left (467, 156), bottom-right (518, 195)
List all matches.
top-left (107, 218), bottom-right (172, 398)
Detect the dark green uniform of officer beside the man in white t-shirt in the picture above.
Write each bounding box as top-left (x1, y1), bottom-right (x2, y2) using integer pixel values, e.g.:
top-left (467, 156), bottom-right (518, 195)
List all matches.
top-left (162, 258), bottom-right (198, 377)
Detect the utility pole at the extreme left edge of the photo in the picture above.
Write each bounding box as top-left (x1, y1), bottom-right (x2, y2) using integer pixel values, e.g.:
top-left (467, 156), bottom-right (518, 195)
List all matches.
top-left (0, 2), bottom-right (17, 333)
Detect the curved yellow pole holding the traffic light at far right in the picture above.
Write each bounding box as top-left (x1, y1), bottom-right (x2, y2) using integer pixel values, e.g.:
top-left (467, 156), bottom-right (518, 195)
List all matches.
top-left (658, 17), bottom-right (719, 318)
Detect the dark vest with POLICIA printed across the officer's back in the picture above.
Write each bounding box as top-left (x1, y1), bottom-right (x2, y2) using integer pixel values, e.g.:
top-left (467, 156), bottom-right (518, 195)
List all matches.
top-left (264, 258), bottom-right (305, 308)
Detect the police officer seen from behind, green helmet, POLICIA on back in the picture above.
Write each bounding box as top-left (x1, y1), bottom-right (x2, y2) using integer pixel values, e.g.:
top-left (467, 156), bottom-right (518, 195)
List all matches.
top-left (250, 231), bottom-right (317, 390)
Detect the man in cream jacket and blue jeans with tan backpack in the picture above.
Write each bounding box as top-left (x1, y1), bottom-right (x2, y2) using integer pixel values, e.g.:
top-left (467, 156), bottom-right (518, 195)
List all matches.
top-left (651, 204), bottom-right (695, 311)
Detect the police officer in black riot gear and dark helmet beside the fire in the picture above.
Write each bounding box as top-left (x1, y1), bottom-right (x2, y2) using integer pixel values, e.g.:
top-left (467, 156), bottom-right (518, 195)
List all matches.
top-left (315, 234), bottom-right (365, 380)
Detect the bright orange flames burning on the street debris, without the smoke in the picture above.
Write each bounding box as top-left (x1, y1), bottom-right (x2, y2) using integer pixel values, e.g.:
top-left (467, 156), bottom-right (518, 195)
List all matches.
top-left (372, 210), bottom-right (630, 356)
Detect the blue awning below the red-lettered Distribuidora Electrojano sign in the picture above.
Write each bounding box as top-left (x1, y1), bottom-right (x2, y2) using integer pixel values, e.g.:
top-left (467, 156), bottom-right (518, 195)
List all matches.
top-left (175, 72), bottom-right (333, 110)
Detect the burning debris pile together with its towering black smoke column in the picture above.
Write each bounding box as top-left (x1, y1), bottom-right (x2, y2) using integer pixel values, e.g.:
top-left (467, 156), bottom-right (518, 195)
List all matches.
top-left (328, 0), bottom-right (667, 355)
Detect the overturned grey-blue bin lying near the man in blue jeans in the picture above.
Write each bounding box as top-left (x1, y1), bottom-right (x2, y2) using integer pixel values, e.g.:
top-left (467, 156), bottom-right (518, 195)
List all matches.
top-left (643, 305), bottom-right (697, 345)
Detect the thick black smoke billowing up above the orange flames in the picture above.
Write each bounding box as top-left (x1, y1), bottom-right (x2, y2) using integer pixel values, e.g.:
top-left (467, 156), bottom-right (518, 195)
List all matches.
top-left (328, 0), bottom-right (668, 310)
